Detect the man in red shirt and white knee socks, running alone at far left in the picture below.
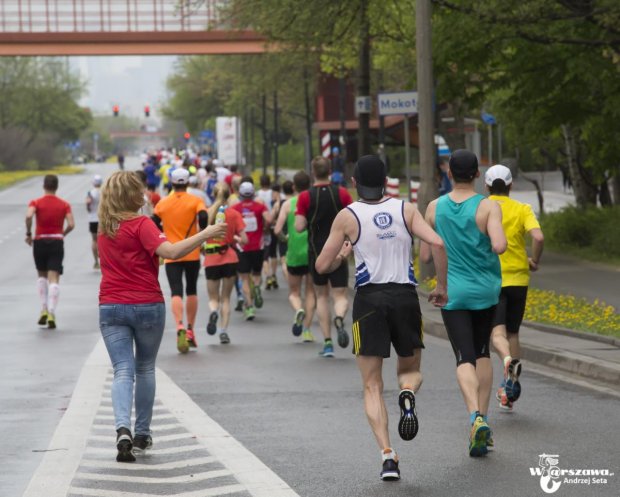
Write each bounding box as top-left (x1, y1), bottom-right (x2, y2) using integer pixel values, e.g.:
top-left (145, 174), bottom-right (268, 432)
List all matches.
top-left (26, 174), bottom-right (75, 329)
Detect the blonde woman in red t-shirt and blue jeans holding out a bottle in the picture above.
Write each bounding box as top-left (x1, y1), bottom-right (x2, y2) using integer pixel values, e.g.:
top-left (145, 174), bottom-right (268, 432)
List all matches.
top-left (97, 171), bottom-right (227, 462)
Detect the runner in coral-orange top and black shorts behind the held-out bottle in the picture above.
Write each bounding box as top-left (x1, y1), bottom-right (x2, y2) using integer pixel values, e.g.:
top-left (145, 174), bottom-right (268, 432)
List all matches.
top-left (204, 183), bottom-right (248, 344)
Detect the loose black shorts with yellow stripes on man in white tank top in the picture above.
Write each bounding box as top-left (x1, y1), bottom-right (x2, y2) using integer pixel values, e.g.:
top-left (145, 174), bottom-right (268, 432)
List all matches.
top-left (353, 283), bottom-right (424, 357)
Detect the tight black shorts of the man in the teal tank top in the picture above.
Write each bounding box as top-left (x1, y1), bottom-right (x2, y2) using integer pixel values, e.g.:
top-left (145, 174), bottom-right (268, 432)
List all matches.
top-left (441, 306), bottom-right (496, 366)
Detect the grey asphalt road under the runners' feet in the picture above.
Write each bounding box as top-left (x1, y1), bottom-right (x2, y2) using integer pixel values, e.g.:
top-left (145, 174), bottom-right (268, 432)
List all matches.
top-left (0, 161), bottom-right (620, 497)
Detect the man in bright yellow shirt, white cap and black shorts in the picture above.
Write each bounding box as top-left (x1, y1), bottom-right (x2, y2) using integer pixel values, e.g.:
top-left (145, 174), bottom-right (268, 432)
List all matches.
top-left (484, 164), bottom-right (544, 410)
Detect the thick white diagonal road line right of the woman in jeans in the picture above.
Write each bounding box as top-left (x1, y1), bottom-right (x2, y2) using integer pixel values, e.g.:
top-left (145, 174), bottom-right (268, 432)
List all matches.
top-left (157, 369), bottom-right (299, 497)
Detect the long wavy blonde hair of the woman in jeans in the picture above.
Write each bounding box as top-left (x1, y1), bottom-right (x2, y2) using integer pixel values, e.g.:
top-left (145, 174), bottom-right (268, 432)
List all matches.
top-left (98, 171), bottom-right (144, 238)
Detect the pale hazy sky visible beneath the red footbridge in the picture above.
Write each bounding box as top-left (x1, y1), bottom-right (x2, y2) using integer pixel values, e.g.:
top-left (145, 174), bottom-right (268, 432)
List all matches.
top-left (70, 56), bottom-right (176, 119)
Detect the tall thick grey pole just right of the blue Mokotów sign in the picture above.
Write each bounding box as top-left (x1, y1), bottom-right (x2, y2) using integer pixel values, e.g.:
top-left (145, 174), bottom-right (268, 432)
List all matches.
top-left (416, 0), bottom-right (437, 280)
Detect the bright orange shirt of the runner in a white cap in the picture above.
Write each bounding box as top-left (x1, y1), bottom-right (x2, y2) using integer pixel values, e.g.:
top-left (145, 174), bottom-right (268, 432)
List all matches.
top-left (153, 192), bottom-right (207, 262)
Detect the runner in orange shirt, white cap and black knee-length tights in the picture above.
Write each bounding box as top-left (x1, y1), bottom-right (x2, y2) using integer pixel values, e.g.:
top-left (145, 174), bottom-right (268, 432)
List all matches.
top-left (153, 168), bottom-right (208, 353)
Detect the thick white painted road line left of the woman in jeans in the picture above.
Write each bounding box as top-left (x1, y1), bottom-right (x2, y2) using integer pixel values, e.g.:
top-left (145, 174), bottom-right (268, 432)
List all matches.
top-left (23, 340), bottom-right (110, 497)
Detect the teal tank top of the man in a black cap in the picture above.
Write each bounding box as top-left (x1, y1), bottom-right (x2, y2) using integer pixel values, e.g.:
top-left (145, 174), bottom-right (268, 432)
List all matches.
top-left (435, 194), bottom-right (502, 310)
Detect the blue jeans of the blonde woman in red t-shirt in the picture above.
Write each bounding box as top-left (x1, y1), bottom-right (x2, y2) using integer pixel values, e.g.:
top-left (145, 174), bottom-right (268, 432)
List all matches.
top-left (99, 303), bottom-right (166, 435)
